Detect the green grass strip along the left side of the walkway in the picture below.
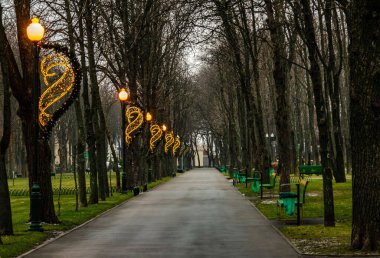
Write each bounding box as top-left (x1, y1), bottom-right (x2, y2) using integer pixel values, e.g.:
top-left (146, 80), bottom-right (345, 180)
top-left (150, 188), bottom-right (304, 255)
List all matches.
top-left (0, 174), bottom-right (171, 258)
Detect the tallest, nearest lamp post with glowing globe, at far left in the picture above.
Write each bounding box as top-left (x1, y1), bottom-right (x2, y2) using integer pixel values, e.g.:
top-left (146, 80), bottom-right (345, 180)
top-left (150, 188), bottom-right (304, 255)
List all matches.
top-left (26, 18), bottom-right (45, 231)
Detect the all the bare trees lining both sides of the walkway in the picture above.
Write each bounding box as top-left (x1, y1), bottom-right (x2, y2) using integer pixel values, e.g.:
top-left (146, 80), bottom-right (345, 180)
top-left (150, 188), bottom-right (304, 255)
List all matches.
top-left (0, 0), bottom-right (380, 250)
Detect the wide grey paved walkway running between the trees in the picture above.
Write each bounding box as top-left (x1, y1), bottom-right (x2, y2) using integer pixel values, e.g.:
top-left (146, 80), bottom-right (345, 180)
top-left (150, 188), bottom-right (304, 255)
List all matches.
top-left (25, 169), bottom-right (298, 258)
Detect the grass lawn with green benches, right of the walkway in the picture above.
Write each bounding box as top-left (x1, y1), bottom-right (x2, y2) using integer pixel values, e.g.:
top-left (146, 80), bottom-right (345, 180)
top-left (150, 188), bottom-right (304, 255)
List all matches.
top-left (233, 175), bottom-right (380, 255)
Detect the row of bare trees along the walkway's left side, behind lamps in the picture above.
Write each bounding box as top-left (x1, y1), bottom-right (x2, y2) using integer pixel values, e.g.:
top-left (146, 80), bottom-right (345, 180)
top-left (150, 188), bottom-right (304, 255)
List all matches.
top-left (0, 0), bottom-right (198, 241)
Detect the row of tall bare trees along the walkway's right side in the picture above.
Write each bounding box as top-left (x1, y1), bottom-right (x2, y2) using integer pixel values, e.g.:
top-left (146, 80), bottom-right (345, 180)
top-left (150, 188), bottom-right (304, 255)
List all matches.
top-left (189, 0), bottom-right (380, 249)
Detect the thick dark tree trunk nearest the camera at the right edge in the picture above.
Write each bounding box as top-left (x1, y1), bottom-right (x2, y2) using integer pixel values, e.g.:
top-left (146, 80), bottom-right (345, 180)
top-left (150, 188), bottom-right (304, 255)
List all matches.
top-left (347, 0), bottom-right (380, 250)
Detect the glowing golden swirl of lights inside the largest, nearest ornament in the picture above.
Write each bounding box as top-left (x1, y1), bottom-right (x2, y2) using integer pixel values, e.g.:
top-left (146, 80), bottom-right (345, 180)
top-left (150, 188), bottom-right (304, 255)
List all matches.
top-left (38, 53), bottom-right (75, 127)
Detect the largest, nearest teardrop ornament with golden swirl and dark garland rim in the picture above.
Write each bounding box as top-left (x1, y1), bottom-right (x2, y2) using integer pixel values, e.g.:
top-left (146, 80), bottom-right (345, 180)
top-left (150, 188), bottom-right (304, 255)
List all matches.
top-left (38, 42), bottom-right (82, 140)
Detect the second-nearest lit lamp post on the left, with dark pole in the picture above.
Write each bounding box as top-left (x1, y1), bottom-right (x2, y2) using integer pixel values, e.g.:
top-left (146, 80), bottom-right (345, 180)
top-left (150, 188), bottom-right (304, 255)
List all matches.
top-left (118, 88), bottom-right (129, 194)
